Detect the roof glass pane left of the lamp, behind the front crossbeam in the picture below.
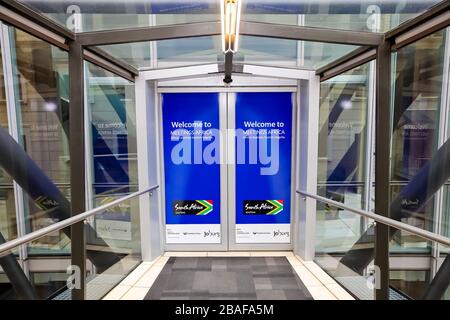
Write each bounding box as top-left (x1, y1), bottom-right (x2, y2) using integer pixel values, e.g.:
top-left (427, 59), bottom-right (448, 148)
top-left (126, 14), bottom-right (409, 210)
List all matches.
top-left (99, 36), bottom-right (224, 68)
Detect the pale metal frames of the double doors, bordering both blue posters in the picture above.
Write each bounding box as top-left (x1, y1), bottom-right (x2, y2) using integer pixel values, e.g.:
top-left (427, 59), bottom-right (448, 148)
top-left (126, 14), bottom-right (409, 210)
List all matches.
top-left (158, 83), bottom-right (297, 251)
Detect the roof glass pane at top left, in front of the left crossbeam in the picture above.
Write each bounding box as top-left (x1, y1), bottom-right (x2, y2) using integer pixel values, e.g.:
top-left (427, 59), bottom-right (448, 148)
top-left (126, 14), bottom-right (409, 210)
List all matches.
top-left (19, 0), bottom-right (220, 32)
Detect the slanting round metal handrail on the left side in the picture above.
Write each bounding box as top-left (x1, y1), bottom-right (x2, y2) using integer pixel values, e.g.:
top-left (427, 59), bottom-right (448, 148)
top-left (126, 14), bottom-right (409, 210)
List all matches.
top-left (0, 185), bottom-right (159, 256)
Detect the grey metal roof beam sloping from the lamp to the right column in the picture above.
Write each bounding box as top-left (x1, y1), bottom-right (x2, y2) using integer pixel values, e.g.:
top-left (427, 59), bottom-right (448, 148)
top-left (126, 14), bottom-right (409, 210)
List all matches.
top-left (239, 21), bottom-right (383, 47)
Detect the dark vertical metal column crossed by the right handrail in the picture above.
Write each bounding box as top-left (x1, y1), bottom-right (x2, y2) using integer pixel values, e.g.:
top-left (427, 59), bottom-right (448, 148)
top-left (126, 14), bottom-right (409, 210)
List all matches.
top-left (375, 41), bottom-right (391, 300)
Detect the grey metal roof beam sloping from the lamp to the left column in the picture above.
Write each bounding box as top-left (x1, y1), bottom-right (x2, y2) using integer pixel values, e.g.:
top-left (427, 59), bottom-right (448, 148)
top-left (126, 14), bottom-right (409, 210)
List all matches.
top-left (77, 21), bottom-right (222, 46)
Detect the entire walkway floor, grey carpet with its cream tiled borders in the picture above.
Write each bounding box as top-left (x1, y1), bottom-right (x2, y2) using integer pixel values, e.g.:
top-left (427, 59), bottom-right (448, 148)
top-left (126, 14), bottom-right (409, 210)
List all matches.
top-left (104, 252), bottom-right (353, 300)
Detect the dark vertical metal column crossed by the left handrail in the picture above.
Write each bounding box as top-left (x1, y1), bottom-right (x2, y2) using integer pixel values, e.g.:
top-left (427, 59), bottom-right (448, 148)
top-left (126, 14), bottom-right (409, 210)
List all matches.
top-left (69, 41), bottom-right (86, 300)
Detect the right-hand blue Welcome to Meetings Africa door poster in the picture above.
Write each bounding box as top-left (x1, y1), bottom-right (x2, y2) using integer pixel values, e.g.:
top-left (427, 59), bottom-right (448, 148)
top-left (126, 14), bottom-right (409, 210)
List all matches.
top-left (235, 92), bottom-right (293, 243)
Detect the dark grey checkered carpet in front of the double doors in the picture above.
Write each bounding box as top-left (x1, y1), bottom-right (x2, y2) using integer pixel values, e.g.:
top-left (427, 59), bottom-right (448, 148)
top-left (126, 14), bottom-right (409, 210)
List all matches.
top-left (145, 257), bottom-right (312, 300)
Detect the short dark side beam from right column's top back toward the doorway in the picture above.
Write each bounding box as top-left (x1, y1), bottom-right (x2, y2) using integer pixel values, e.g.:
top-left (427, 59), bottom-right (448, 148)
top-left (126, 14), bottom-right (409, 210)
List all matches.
top-left (316, 47), bottom-right (376, 81)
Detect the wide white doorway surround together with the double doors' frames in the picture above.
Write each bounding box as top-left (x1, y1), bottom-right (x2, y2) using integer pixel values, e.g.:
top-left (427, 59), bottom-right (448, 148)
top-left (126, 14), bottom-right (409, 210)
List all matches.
top-left (136, 65), bottom-right (320, 255)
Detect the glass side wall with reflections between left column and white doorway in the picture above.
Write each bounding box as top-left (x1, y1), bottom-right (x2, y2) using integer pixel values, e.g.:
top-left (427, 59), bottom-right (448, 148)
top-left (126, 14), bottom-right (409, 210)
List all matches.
top-left (86, 63), bottom-right (141, 298)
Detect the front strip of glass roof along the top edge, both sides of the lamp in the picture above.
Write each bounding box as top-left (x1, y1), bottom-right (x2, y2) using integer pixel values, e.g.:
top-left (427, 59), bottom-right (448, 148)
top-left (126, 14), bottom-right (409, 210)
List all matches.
top-left (20, 0), bottom-right (440, 32)
